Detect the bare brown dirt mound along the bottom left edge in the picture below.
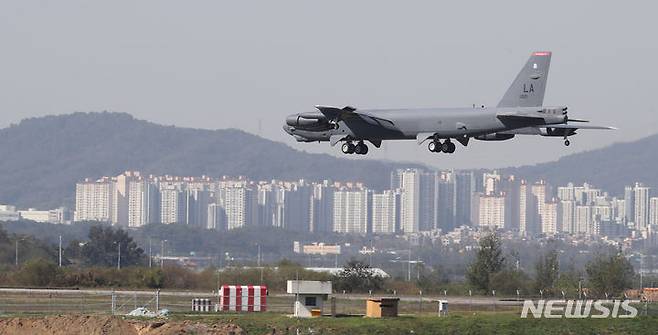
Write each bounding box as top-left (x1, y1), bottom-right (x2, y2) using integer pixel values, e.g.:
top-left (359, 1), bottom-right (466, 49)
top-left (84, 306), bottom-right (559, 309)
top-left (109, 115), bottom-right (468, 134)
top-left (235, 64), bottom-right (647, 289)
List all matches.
top-left (0, 315), bottom-right (245, 335)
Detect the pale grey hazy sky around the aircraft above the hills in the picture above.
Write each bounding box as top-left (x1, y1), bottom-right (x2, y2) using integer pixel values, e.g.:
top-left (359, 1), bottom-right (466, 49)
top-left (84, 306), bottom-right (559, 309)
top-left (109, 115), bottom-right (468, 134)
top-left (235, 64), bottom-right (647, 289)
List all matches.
top-left (0, 0), bottom-right (658, 168)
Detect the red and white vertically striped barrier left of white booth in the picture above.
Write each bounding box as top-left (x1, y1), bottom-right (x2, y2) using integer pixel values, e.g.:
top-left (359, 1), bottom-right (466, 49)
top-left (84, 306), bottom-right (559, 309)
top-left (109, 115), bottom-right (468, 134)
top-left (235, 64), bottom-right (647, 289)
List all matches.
top-left (219, 285), bottom-right (267, 312)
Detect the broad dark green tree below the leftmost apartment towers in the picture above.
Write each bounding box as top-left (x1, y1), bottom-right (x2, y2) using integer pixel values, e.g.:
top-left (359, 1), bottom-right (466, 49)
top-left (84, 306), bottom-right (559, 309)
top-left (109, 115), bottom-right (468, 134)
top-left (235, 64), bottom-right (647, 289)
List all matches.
top-left (80, 225), bottom-right (145, 266)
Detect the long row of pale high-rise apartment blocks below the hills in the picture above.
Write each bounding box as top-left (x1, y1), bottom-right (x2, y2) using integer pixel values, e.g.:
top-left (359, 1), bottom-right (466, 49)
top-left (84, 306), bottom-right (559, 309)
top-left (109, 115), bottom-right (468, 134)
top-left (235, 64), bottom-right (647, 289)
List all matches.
top-left (0, 169), bottom-right (658, 248)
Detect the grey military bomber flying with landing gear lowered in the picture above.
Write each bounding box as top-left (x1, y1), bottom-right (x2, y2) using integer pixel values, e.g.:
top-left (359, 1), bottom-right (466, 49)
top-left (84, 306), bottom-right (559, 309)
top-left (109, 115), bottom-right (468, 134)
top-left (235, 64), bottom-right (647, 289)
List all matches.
top-left (283, 51), bottom-right (615, 155)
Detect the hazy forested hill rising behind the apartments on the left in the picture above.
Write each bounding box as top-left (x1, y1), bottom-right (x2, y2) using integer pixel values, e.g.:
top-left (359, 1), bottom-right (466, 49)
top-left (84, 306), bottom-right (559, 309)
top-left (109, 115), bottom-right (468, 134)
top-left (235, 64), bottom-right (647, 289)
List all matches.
top-left (0, 112), bottom-right (420, 209)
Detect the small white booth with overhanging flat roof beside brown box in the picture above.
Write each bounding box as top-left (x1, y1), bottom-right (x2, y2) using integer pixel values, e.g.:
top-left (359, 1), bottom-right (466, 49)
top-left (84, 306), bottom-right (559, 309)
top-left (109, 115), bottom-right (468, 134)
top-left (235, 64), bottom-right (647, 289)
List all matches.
top-left (286, 280), bottom-right (331, 318)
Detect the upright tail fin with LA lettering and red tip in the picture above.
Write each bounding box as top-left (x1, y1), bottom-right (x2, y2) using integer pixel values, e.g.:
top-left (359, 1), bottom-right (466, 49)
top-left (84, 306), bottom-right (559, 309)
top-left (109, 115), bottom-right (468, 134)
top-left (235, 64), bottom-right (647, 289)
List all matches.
top-left (498, 51), bottom-right (551, 107)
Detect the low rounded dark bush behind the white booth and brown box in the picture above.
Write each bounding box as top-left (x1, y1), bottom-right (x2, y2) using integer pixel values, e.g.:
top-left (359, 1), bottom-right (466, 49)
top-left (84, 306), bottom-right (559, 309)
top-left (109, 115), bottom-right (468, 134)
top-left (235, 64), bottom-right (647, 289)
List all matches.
top-left (334, 259), bottom-right (384, 292)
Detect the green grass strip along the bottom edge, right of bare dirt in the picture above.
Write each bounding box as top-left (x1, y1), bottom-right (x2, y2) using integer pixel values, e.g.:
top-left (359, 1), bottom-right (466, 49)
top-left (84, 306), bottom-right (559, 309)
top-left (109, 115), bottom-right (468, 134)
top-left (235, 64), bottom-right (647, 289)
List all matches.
top-left (172, 313), bottom-right (658, 335)
